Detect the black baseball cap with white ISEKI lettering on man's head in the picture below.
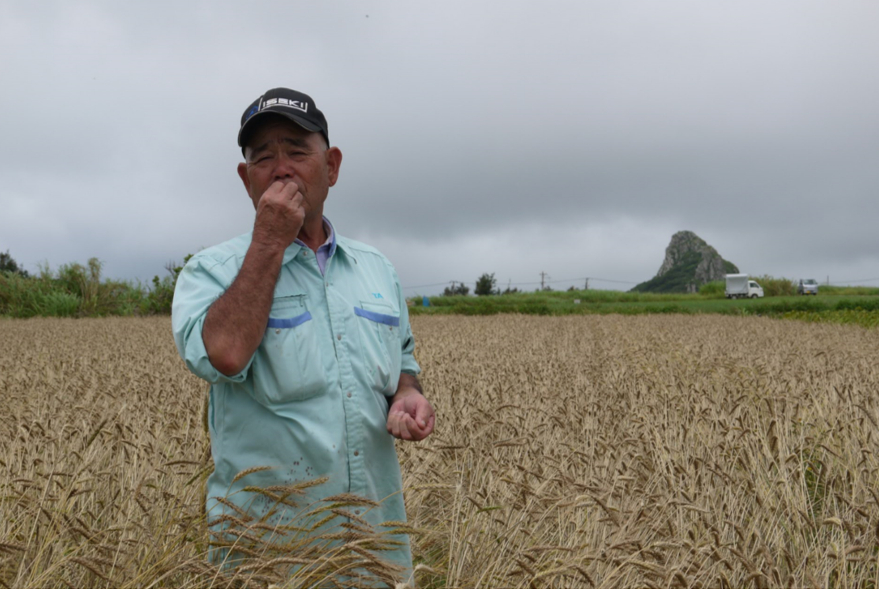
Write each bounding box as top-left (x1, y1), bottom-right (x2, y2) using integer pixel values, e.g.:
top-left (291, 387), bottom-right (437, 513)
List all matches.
top-left (238, 88), bottom-right (330, 153)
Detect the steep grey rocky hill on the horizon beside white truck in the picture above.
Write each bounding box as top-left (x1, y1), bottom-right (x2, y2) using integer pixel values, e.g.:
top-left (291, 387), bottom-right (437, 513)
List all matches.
top-left (632, 231), bottom-right (739, 292)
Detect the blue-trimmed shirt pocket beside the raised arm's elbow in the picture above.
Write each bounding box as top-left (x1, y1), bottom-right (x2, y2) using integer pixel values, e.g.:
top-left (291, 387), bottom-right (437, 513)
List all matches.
top-left (253, 295), bottom-right (327, 405)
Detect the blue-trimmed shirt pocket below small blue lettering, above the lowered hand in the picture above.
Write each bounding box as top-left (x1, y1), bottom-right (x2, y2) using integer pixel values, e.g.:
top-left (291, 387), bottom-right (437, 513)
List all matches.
top-left (354, 301), bottom-right (403, 395)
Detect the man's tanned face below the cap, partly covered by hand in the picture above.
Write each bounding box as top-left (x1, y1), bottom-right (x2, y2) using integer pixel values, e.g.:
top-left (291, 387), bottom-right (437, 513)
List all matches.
top-left (238, 116), bottom-right (342, 222)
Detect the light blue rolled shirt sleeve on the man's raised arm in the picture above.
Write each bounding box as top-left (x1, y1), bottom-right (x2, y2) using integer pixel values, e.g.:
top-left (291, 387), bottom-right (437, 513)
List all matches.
top-left (171, 257), bottom-right (253, 384)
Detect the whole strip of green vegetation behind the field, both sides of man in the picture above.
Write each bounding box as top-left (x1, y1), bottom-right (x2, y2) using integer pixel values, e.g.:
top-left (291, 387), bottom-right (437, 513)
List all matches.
top-left (0, 246), bottom-right (879, 327)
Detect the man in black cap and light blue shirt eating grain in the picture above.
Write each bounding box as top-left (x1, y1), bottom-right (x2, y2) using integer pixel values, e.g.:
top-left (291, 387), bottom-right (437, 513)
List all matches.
top-left (172, 88), bottom-right (434, 580)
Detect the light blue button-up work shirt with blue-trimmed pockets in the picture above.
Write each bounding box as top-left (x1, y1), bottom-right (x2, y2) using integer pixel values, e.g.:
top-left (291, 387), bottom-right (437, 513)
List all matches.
top-left (172, 220), bottom-right (420, 568)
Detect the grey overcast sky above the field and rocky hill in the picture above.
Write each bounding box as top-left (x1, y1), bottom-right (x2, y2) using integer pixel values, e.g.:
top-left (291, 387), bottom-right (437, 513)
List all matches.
top-left (0, 0), bottom-right (879, 294)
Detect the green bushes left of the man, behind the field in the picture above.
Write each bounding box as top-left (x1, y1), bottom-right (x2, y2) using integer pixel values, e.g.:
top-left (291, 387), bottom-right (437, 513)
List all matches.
top-left (0, 252), bottom-right (191, 317)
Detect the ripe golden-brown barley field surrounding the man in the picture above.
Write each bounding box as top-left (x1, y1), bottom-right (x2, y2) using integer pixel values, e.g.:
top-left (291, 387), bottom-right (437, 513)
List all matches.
top-left (0, 315), bottom-right (879, 588)
